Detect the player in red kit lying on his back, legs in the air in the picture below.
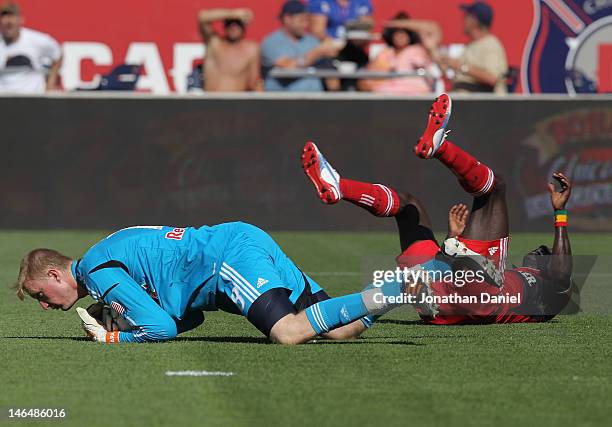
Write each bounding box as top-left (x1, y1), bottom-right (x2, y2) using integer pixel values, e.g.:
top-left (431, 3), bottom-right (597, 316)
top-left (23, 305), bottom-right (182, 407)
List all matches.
top-left (302, 94), bottom-right (572, 324)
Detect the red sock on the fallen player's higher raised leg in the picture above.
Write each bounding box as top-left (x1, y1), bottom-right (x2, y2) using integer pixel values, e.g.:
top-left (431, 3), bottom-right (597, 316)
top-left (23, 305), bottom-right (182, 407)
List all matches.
top-left (436, 141), bottom-right (495, 197)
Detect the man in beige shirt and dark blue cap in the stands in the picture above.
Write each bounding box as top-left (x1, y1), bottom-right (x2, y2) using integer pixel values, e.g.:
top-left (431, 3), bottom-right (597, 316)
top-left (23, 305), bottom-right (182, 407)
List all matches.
top-left (434, 1), bottom-right (508, 94)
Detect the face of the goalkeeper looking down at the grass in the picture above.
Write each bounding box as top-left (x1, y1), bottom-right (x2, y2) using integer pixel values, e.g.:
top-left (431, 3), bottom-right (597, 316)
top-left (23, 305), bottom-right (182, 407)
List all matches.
top-left (28, 269), bottom-right (79, 311)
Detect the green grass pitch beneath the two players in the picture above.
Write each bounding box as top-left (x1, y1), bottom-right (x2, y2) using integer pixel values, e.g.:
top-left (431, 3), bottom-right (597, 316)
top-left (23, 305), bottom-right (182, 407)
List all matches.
top-left (0, 231), bottom-right (612, 427)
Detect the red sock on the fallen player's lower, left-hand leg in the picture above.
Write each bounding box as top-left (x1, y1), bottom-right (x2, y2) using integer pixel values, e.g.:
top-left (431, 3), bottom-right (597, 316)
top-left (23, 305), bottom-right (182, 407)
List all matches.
top-left (340, 178), bottom-right (399, 216)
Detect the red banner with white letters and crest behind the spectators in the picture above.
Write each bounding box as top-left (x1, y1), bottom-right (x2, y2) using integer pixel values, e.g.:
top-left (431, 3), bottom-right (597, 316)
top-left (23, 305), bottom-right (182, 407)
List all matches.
top-left (20, 0), bottom-right (612, 94)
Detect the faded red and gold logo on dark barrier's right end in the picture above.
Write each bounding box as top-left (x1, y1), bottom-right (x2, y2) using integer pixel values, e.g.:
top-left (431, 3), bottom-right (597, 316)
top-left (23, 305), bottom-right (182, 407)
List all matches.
top-left (517, 108), bottom-right (612, 230)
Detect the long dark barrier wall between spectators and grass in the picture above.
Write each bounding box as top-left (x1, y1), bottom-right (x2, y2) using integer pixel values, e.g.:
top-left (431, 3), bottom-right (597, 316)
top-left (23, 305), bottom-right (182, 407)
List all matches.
top-left (0, 98), bottom-right (612, 231)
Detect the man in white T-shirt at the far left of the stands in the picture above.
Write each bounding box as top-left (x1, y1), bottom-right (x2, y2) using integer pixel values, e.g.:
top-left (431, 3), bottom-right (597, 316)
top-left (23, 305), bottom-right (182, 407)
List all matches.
top-left (0, 2), bottom-right (62, 93)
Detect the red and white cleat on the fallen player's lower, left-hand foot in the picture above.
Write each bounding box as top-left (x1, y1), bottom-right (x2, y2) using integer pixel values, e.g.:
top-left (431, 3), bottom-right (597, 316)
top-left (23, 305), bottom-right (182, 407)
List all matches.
top-left (302, 141), bottom-right (342, 205)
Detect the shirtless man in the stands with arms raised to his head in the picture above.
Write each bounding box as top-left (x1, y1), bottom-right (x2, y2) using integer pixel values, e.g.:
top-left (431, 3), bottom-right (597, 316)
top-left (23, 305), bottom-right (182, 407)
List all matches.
top-left (199, 9), bottom-right (261, 92)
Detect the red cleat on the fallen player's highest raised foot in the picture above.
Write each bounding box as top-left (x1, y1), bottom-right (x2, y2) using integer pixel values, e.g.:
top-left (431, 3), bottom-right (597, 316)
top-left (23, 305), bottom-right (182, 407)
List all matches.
top-left (414, 93), bottom-right (451, 159)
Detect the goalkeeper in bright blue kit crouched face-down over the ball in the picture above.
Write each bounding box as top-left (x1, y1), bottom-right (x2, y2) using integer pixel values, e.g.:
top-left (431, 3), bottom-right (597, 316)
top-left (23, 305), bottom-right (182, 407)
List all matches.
top-left (16, 222), bottom-right (423, 344)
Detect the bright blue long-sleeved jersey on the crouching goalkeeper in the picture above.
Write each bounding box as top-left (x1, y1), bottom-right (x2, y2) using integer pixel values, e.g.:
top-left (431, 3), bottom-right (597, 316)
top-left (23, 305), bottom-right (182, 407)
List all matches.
top-left (72, 223), bottom-right (239, 342)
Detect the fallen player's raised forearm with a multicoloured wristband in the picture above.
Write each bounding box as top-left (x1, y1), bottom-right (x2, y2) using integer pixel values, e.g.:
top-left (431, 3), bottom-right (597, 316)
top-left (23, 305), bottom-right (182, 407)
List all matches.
top-left (547, 172), bottom-right (573, 285)
